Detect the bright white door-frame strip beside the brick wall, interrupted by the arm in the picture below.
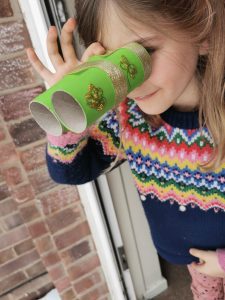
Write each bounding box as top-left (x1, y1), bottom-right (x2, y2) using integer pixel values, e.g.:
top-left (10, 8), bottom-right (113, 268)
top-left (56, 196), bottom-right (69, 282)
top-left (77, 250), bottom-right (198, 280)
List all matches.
top-left (18, 0), bottom-right (125, 300)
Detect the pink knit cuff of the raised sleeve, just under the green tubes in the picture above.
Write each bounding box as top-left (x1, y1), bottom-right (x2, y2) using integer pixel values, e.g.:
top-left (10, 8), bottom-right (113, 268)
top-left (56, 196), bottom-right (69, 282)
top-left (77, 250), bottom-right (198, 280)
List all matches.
top-left (47, 129), bottom-right (89, 148)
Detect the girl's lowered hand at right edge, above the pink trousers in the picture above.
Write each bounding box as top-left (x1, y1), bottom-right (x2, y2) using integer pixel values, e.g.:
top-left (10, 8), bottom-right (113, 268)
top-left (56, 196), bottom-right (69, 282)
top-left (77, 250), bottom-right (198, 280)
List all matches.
top-left (189, 248), bottom-right (225, 278)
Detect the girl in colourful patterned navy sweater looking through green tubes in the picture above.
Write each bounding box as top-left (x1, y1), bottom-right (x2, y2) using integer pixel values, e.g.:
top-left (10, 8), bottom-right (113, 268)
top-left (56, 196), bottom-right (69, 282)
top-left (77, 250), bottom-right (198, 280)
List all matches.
top-left (28, 0), bottom-right (225, 299)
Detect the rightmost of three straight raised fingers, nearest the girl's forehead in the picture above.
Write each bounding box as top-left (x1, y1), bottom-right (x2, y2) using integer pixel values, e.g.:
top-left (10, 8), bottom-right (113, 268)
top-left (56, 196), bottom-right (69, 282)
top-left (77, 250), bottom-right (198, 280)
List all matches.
top-left (60, 18), bottom-right (77, 63)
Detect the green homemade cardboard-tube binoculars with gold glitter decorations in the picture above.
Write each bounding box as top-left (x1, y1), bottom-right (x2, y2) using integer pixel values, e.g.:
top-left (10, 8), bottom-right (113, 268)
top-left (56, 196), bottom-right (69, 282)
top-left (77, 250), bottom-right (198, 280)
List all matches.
top-left (30, 43), bottom-right (151, 136)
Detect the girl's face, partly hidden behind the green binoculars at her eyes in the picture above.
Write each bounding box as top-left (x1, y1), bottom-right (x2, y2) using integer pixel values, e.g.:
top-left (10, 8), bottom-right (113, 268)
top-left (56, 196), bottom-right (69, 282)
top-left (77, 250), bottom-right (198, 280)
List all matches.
top-left (102, 6), bottom-right (199, 115)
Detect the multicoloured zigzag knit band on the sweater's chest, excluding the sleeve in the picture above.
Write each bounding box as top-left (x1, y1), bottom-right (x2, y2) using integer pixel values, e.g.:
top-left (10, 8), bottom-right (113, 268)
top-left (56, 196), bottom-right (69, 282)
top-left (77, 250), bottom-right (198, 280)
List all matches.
top-left (121, 100), bottom-right (225, 211)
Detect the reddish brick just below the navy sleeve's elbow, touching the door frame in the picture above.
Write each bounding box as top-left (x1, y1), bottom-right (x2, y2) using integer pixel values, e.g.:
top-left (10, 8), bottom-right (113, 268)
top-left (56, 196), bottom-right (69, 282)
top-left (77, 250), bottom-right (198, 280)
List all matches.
top-left (40, 185), bottom-right (79, 215)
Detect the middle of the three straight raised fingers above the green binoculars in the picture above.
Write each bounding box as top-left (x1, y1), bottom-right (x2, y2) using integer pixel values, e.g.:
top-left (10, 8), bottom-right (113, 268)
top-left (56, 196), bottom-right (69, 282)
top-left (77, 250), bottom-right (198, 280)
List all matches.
top-left (47, 26), bottom-right (64, 71)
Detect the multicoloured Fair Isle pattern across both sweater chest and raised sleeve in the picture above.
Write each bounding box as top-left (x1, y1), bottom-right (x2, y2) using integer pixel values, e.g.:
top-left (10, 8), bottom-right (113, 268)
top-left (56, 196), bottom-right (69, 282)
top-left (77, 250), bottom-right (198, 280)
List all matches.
top-left (48, 99), bottom-right (225, 211)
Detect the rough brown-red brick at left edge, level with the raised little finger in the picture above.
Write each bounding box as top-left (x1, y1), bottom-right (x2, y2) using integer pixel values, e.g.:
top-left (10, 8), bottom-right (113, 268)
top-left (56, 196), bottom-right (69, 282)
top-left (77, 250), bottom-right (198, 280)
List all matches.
top-left (0, 55), bottom-right (36, 91)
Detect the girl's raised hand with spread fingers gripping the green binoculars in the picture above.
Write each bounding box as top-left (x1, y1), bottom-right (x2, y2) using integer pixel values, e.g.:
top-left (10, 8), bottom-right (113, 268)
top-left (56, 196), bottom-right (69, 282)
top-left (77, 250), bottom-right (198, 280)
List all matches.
top-left (27, 18), bottom-right (105, 86)
